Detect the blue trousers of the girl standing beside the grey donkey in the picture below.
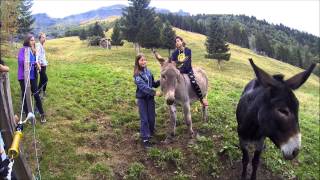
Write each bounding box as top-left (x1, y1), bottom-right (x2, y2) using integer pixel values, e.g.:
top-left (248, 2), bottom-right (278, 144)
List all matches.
top-left (138, 98), bottom-right (156, 140)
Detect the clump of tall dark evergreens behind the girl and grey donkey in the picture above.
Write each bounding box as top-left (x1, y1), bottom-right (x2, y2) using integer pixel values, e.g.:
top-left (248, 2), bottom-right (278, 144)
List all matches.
top-left (118, 0), bottom-right (176, 54)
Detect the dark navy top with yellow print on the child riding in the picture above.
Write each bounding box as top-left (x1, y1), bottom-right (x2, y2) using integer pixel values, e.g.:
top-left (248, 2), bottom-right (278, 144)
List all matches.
top-left (171, 47), bottom-right (192, 74)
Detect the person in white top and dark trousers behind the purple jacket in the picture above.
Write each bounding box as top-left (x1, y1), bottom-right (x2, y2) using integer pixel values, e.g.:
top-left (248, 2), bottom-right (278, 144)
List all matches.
top-left (36, 32), bottom-right (48, 98)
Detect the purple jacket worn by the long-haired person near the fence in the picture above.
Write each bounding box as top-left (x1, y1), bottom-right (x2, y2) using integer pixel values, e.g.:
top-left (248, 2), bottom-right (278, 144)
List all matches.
top-left (18, 47), bottom-right (36, 80)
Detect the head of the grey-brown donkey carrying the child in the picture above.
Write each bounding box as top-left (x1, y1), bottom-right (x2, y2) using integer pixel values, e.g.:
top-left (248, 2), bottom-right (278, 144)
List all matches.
top-left (152, 50), bottom-right (180, 105)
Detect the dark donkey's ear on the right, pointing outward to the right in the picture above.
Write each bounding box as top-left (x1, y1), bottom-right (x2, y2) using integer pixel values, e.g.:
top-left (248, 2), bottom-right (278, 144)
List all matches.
top-left (286, 63), bottom-right (316, 90)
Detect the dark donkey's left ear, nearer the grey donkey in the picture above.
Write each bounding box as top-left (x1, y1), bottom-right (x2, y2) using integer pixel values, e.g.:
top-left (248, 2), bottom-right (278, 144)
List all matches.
top-left (249, 58), bottom-right (276, 87)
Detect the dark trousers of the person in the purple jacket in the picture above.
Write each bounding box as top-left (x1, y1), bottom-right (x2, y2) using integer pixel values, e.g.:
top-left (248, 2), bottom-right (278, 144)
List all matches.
top-left (19, 79), bottom-right (44, 115)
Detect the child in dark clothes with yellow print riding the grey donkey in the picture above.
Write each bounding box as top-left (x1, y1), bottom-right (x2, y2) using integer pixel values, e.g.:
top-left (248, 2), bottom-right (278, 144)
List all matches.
top-left (171, 36), bottom-right (208, 106)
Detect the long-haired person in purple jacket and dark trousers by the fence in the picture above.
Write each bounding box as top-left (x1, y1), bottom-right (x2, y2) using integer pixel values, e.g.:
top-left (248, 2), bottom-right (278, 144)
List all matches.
top-left (18, 34), bottom-right (46, 123)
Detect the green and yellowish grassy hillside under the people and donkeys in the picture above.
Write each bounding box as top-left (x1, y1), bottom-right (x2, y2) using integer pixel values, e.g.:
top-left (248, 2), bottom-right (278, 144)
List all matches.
top-left (1, 29), bottom-right (320, 179)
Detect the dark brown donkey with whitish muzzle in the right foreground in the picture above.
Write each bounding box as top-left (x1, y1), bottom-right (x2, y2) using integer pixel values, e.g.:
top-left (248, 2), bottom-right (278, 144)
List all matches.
top-left (236, 59), bottom-right (315, 179)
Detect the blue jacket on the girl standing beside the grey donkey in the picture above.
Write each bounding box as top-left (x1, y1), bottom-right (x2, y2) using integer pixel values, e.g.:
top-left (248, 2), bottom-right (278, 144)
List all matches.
top-left (134, 68), bottom-right (160, 99)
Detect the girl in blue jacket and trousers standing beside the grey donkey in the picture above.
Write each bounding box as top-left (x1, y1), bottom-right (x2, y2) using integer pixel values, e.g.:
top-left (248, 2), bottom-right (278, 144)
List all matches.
top-left (134, 54), bottom-right (160, 149)
